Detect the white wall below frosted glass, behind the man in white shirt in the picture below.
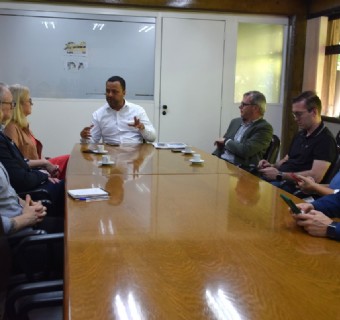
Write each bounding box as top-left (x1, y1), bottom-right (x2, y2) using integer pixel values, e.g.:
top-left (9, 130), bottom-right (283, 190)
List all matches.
top-left (29, 98), bottom-right (155, 157)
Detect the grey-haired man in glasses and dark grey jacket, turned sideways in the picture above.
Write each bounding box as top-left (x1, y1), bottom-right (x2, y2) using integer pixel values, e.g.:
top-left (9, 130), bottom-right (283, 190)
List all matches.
top-left (213, 91), bottom-right (273, 167)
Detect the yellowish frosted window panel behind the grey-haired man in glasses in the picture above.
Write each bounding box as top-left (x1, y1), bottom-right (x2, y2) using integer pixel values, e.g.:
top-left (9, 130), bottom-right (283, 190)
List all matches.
top-left (234, 23), bottom-right (284, 103)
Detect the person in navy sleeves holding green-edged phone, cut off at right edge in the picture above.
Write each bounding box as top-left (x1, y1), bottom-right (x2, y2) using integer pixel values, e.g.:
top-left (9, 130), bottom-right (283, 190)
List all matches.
top-left (293, 192), bottom-right (340, 240)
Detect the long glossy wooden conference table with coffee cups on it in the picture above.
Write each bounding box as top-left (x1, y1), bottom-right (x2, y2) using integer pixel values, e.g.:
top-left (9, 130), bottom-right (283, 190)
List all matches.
top-left (64, 144), bottom-right (340, 320)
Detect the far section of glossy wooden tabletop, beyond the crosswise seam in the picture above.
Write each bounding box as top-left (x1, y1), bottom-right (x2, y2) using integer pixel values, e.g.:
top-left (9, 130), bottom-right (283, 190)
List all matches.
top-left (67, 143), bottom-right (234, 175)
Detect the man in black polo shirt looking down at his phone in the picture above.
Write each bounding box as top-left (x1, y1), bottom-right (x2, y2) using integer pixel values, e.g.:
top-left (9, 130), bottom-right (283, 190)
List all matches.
top-left (258, 91), bottom-right (337, 193)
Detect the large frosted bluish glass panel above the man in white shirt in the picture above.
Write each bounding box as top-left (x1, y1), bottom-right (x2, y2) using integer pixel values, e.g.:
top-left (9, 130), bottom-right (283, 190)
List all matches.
top-left (0, 10), bottom-right (155, 100)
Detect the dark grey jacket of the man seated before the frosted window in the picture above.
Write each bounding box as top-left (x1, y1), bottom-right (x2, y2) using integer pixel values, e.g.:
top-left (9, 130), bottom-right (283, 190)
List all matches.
top-left (213, 118), bottom-right (273, 166)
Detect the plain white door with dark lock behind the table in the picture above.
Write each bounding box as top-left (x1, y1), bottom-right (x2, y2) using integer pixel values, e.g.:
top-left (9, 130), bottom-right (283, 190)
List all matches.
top-left (159, 18), bottom-right (225, 152)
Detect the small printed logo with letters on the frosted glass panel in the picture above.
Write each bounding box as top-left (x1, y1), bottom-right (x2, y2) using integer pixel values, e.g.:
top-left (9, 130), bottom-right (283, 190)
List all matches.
top-left (64, 41), bottom-right (88, 72)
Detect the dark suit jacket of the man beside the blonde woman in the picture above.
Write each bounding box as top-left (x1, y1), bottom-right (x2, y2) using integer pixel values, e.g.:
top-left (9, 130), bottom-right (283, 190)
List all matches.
top-left (0, 132), bottom-right (48, 193)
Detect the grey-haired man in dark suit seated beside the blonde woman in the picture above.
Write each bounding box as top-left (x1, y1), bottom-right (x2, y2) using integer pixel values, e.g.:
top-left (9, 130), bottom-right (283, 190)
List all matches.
top-left (0, 84), bottom-right (65, 216)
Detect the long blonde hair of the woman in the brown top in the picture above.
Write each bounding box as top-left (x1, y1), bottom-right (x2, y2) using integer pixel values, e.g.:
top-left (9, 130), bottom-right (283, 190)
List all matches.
top-left (9, 84), bottom-right (30, 128)
